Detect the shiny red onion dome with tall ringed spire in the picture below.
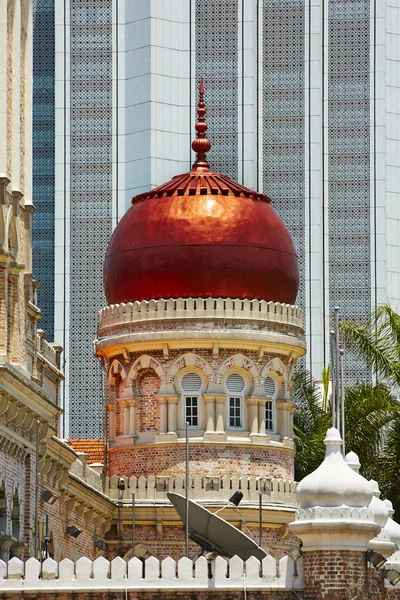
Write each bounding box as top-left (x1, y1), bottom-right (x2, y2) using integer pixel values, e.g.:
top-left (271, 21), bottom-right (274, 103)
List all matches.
top-left (104, 82), bottom-right (299, 304)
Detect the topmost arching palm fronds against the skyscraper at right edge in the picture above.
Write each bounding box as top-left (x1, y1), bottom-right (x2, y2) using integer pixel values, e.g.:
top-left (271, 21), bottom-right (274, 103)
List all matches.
top-left (340, 304), bottom-right (400, 388)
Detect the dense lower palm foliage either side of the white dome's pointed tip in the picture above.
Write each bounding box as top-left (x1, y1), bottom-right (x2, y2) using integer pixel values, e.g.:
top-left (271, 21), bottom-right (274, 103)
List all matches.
top-left (293, 371), bottom-right (400, 516)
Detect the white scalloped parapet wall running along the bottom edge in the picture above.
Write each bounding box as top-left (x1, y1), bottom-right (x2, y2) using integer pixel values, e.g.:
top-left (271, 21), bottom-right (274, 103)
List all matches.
top-left (0, 556), bottom-right (303, 594)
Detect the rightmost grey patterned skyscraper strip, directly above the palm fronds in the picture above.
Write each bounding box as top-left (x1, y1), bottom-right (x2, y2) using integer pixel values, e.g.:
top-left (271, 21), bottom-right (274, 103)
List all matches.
top-left (328, 0), bottom-right (371, 384)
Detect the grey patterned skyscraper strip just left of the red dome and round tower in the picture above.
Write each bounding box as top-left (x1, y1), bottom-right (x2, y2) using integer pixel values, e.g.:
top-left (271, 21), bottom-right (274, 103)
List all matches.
top-left (69, 0), bottom-right (112, 437)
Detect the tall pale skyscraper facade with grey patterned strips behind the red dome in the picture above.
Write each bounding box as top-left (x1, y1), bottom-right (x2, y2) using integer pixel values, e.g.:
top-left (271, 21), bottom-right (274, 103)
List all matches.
top-left (34, 0), bottom-right (400, 437)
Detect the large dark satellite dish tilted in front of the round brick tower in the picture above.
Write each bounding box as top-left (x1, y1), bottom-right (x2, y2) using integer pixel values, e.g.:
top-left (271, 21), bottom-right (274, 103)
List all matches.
top-left (167, 493), bottom-right (267, 561)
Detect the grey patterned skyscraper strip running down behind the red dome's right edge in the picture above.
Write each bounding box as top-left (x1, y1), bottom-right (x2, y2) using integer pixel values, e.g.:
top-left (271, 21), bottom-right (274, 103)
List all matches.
top-left (262, 0), bottom-right (305, 336)
